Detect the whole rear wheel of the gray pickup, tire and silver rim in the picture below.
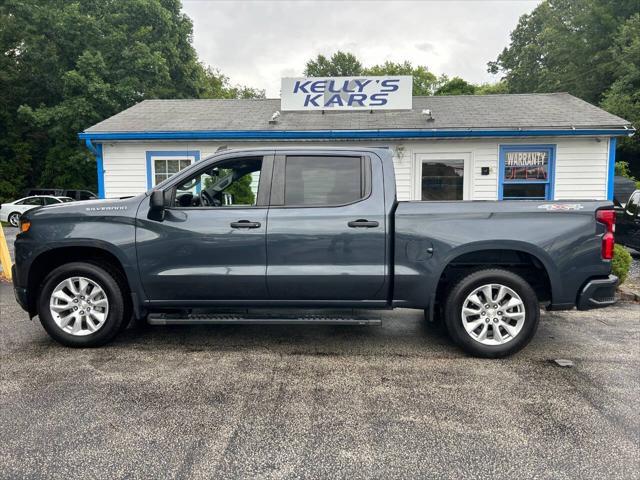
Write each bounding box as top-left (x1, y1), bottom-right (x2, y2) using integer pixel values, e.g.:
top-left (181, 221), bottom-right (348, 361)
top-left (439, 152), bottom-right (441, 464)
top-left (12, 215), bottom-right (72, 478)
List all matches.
top-left (444, 268), bottom-right (540, 358)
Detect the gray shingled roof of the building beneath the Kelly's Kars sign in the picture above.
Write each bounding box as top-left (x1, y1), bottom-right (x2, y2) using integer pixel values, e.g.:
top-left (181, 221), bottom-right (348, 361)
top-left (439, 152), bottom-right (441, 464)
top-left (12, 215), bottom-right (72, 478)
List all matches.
top-left (85, 93), bottom-right (631, 133)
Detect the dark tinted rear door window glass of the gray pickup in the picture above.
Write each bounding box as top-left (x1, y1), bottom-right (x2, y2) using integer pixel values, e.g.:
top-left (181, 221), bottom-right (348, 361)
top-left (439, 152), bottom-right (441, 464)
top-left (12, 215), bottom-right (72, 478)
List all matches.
top-left (284, 156), bottom-right (364, 206)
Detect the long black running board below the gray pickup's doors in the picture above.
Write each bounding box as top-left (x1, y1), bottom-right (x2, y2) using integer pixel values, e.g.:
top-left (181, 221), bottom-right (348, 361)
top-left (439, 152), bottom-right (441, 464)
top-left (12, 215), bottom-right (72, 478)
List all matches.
top-left (147, 310), bottom-right (382, 326)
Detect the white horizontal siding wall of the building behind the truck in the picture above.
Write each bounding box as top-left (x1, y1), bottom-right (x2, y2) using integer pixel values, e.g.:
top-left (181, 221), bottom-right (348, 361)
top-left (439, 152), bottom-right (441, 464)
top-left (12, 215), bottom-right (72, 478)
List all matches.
top-left (103, 137), bottom-right (609, 200)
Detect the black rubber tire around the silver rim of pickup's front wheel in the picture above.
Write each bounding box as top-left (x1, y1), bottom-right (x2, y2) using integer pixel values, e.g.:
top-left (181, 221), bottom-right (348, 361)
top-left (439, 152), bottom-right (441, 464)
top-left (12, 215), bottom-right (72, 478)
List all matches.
top-left (38, 262), bottom-right (129, 348)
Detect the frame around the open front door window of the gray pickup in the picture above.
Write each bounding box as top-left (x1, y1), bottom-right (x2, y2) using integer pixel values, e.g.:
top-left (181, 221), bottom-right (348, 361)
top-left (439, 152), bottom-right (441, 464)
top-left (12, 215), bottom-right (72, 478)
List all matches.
top-left (162, 154), bottom-right (273, 210)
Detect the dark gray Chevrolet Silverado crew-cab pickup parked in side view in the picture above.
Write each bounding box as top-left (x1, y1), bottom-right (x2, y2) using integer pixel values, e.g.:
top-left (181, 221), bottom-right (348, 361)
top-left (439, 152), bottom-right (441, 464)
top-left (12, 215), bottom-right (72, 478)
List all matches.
top-left (13, 148), bottom-right (617, 357)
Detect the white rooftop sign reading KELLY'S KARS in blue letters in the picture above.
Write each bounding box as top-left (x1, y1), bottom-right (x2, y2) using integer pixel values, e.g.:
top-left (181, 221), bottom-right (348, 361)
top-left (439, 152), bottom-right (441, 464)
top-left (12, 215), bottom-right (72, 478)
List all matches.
top-left (280, 75), bottom-right (413, 111)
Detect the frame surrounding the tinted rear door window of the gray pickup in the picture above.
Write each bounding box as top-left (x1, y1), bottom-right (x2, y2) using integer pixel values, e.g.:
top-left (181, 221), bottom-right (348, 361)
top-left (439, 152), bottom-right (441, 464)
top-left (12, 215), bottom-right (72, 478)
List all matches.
top-left (269, 151), bottom-right (372, 208)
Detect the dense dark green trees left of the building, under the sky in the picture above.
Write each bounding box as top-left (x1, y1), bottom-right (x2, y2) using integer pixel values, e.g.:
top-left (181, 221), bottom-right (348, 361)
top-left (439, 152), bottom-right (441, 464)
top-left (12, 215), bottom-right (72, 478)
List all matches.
top-left (0, 0), bottom-right (264, 200)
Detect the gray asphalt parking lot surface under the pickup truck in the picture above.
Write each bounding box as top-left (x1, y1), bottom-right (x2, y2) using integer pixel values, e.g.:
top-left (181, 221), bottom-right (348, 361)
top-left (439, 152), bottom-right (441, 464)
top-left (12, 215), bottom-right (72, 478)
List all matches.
top-left (0, 226), bottom-right (640, 479)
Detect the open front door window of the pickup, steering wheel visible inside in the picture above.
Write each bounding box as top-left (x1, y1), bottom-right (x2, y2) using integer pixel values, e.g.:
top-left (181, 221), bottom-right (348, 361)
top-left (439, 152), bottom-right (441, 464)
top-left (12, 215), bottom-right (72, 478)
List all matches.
top-left (174, 157), bottom-right (262, 208)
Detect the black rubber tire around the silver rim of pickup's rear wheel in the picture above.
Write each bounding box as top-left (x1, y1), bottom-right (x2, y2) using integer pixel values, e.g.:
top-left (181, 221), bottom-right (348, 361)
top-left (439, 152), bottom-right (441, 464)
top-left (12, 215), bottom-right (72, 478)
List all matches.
top-left (444, 268), bottom-right (540, 358)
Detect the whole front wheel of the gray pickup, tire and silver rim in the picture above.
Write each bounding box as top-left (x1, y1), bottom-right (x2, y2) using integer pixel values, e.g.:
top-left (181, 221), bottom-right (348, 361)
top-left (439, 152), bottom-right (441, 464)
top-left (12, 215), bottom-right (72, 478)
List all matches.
top-left (38, 262), bottom-right (125, 347)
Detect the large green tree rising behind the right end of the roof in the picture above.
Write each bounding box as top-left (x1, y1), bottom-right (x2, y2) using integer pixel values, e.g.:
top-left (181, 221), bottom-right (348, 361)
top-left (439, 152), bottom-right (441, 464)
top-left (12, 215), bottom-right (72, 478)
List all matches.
top-left (489, 0), bottom-right (638, 103)
